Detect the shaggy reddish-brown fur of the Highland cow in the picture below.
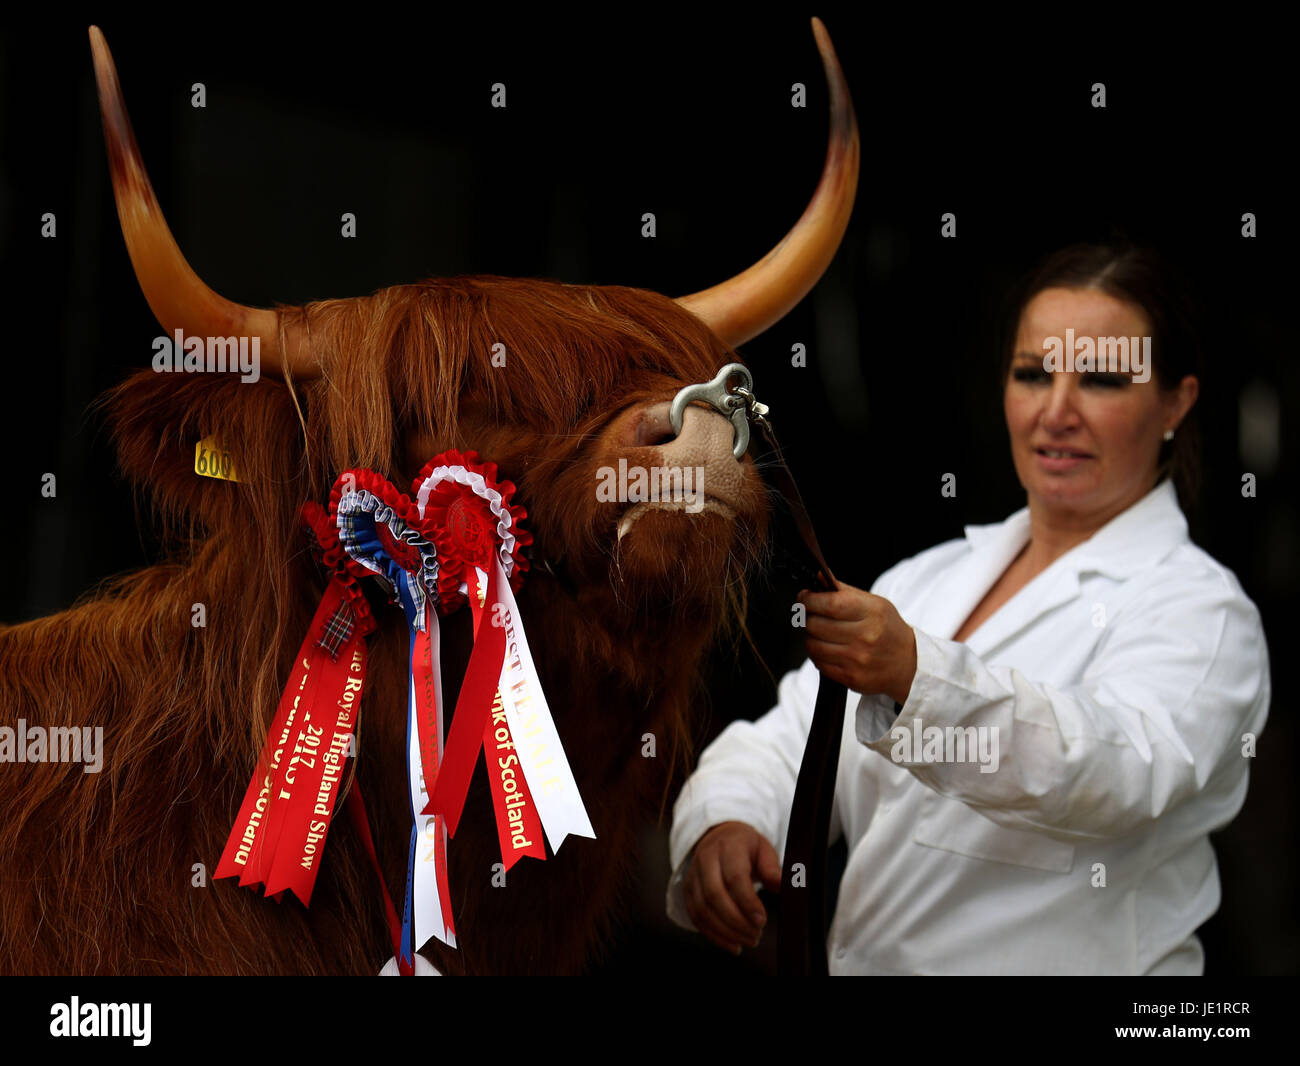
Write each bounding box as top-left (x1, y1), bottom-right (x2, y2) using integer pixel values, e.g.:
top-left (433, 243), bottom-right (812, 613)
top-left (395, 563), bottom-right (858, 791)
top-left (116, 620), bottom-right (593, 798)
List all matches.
top-left (0, 277), bottom-right (766, 974)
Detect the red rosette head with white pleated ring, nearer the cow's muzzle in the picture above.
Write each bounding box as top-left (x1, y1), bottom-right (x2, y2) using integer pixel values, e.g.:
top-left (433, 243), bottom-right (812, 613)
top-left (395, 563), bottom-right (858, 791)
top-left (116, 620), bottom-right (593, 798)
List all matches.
top-left (411, 449), bottom-right (533, 614)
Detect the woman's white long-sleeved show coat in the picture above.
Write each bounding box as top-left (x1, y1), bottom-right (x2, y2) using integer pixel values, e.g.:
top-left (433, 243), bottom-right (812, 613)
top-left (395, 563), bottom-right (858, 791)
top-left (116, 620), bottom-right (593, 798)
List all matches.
top-left (668, 481), bottom-right (1270, 974)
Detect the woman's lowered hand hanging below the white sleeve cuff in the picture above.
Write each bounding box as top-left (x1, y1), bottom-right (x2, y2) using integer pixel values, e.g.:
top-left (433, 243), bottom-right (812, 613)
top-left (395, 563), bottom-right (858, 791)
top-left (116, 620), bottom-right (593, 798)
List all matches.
top-left (683, 822), bottom-right (781, 954)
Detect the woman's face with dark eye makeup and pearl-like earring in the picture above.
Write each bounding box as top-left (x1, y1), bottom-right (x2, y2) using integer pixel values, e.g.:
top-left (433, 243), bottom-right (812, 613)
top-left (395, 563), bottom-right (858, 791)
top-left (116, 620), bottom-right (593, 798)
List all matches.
top-left (1004, 289), bottom-right (1197, 529)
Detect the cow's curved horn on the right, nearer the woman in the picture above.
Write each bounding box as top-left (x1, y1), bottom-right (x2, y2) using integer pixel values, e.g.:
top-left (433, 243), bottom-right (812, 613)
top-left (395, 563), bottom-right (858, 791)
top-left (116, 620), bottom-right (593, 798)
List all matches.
top-left (677, 18), bottom-right (859, 347)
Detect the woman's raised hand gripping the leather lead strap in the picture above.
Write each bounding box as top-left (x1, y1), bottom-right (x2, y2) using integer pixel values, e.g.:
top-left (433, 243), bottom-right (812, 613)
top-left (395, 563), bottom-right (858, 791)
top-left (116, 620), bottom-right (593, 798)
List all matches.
top-left (800, 585), bottom-right (917, 703)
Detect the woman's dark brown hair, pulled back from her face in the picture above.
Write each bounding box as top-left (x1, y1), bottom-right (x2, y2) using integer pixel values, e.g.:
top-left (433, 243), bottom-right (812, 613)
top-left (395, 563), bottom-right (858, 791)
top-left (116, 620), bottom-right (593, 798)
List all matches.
top-left (998, 241), bottom-right (1204, 512)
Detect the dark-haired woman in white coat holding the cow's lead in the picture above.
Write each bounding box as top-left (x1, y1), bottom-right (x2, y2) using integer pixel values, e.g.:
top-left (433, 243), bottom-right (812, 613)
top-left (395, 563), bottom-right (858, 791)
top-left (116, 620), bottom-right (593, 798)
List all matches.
top-left (668, 246), bottom-right (1270, 974)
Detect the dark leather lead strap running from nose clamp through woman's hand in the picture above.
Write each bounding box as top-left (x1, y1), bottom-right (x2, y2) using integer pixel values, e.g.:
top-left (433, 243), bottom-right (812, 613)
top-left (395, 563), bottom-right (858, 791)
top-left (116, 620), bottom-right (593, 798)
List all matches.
top-left (757, 421), bottom-right (849, 976)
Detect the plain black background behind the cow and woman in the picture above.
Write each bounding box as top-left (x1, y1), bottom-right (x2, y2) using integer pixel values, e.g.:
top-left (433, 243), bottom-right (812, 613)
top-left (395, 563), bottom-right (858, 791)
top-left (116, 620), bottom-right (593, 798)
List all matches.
top-left (0, 5), bottom-right (1300, 975)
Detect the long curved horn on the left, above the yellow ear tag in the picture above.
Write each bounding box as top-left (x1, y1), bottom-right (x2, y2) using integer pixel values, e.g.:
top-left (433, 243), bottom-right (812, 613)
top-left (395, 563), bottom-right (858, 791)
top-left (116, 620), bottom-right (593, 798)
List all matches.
top-left (90, 26), bottom-right (320, 377)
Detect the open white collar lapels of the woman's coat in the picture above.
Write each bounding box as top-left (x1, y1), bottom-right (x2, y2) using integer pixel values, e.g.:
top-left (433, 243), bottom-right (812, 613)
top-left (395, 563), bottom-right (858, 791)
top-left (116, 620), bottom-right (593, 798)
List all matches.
top-left (925, 480), bottom-right (1187, 654)
